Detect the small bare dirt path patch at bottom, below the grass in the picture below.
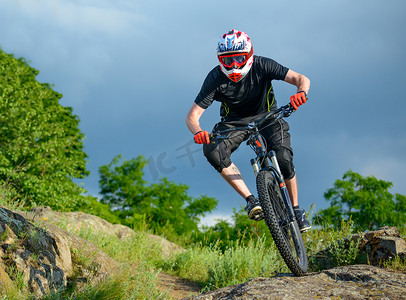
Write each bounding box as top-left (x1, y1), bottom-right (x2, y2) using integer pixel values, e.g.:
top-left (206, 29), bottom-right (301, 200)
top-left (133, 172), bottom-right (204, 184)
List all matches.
top-left (158, 273), bottom-right (201, 299)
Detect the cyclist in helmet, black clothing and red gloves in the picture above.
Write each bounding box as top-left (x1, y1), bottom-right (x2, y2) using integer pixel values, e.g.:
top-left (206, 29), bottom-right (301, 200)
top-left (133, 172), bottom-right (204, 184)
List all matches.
top-left (186, 29), bottom-right (311, 231)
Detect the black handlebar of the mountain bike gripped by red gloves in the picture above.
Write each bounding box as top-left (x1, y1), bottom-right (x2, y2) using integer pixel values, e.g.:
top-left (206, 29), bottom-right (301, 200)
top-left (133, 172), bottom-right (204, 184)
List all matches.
top-left (210, 103), bottom-right (295, 141)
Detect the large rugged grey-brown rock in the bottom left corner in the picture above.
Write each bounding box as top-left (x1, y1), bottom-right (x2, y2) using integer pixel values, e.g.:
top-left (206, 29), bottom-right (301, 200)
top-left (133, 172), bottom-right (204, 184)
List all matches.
top-left (0, 208), bottom-right (71, 296)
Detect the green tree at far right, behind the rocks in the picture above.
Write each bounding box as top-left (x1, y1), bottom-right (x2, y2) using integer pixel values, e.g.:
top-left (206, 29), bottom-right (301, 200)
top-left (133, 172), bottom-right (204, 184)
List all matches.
top-left (316, 170), bottom-right (406, 230)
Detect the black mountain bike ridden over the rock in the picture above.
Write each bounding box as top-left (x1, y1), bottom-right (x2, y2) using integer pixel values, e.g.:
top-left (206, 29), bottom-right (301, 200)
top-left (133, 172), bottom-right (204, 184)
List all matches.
top-left (210, 104), bottom-right (308, 276)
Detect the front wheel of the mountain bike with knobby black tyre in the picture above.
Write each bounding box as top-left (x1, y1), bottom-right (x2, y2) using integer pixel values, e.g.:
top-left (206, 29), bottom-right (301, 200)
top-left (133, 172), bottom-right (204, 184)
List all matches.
top-left (257, 170), bottom-right (308, 276)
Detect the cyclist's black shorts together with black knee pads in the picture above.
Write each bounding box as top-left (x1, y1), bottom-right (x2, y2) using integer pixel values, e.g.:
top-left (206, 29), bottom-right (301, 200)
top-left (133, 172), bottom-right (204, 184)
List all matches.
top-left (203, 119), bottom-right (295, 179)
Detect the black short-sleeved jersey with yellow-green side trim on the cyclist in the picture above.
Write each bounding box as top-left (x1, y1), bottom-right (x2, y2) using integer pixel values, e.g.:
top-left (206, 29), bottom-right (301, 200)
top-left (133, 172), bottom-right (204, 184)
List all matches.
top-left (195, 56), bottom-right (289, 121)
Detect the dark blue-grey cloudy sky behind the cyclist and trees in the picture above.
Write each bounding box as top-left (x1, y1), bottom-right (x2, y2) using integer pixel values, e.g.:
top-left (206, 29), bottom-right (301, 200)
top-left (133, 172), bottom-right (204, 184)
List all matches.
top-left (0, 0), bottom-right (406, 224)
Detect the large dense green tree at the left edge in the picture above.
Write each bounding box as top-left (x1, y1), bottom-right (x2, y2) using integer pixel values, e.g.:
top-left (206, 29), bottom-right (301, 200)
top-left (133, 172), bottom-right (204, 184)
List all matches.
top-left (0, 49), bottom-right (89, 210)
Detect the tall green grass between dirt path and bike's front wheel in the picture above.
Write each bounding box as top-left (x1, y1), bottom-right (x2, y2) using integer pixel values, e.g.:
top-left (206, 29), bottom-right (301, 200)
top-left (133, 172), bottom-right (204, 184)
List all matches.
top-left (162, 238), bottom-right (288, 290)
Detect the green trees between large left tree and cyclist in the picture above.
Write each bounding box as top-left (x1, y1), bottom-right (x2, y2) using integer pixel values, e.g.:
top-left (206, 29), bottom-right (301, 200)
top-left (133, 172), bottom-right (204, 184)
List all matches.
top-left (99, 155), bottom-right (217, 235)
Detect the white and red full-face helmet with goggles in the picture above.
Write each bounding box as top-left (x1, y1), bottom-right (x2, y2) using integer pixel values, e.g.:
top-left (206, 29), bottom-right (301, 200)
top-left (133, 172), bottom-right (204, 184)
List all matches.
top-left (217, 29), bottom-right (254, 82)
